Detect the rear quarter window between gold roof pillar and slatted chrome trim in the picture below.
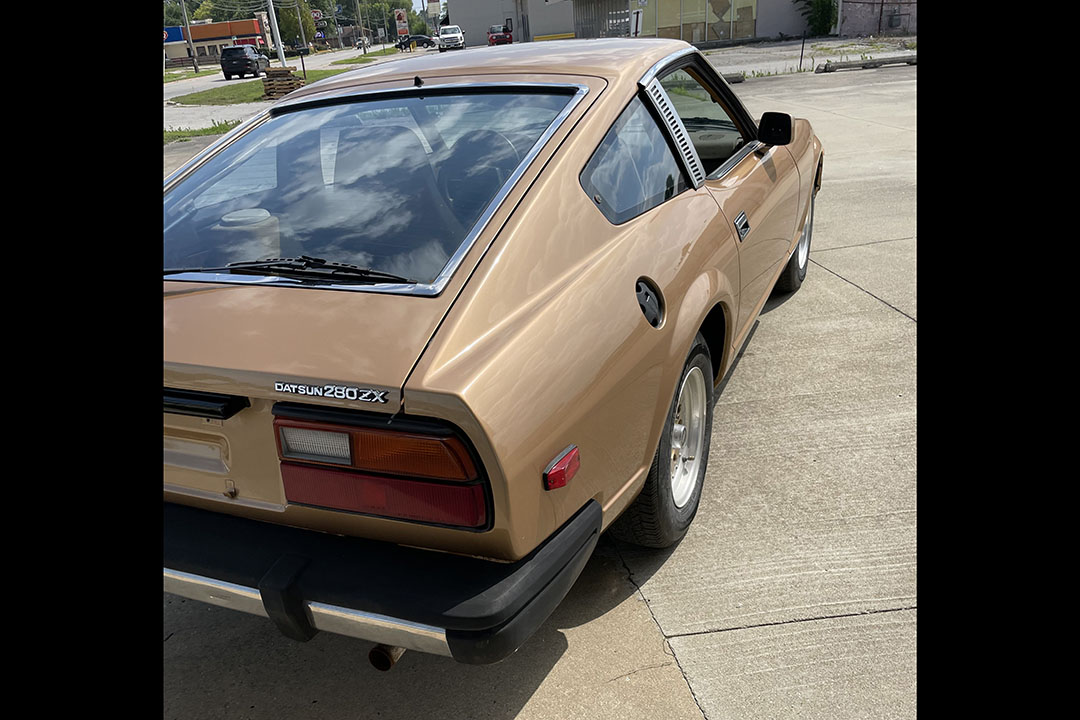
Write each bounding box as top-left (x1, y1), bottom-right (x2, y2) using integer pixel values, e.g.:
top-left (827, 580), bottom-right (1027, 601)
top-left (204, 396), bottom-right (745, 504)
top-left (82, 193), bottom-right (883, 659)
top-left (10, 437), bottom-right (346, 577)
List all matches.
top-left (580, 97), bottom-right (688, 225)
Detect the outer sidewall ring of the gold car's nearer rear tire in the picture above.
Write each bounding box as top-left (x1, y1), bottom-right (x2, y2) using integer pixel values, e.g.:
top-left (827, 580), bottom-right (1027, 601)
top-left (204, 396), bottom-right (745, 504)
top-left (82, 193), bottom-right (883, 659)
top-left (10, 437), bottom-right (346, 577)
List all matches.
top-left (654, 336), bottom-right (713, 538)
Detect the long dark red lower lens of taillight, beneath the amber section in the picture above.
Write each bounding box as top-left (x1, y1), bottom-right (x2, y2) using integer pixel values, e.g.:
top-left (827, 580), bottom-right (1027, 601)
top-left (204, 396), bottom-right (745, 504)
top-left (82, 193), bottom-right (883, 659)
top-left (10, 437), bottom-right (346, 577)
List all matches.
top-left (281, 462), bottom-right (487, 528)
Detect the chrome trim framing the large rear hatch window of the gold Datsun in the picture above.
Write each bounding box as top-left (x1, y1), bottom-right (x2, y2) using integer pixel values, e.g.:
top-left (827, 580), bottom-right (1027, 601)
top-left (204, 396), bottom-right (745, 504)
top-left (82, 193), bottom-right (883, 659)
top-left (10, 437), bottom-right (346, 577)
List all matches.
top-left (164, 83), bottom-right (589, 297)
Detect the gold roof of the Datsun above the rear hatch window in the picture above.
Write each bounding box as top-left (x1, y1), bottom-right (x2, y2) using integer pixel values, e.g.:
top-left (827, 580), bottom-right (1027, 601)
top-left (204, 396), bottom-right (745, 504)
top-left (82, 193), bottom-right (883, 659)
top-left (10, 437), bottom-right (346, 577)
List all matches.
top-left (280, 38), bottom-right (691, 105)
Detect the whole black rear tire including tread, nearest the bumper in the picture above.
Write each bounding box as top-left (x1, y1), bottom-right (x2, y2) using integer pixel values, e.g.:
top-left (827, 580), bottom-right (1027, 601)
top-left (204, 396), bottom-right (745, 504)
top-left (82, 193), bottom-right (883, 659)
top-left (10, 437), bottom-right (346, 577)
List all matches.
top-left (611, 334), bottom-right (713, 547)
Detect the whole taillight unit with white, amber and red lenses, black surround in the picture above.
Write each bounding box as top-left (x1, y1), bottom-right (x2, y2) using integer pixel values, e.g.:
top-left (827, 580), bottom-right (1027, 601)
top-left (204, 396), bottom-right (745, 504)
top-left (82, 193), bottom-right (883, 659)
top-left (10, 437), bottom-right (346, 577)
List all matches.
top-left (273, 406), bottom-right (490, 530)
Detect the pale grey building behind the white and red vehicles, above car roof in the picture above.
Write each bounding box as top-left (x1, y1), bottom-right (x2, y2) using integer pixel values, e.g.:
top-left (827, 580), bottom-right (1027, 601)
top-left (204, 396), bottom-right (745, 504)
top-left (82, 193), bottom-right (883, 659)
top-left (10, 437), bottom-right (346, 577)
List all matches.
top-left (446, 0), bottom-right (578, 47)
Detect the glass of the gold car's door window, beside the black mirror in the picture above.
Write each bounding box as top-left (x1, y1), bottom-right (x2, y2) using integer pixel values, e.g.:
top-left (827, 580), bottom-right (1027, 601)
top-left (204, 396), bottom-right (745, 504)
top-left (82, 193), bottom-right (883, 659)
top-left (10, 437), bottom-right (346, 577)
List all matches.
top-left (660, 70), bottom-right (745, 175)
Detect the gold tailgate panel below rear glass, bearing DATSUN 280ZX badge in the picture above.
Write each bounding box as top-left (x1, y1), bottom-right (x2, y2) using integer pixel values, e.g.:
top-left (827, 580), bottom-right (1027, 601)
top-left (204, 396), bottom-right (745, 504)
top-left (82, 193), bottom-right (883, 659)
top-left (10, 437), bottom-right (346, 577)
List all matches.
top-left (164, 282), bottom-right (453, 508)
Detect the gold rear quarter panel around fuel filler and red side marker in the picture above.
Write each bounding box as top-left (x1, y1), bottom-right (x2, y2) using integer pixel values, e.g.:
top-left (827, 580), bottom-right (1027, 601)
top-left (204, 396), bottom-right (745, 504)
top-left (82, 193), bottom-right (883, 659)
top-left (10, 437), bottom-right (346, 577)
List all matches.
top-left (403, 91), bottom-right (738, 558)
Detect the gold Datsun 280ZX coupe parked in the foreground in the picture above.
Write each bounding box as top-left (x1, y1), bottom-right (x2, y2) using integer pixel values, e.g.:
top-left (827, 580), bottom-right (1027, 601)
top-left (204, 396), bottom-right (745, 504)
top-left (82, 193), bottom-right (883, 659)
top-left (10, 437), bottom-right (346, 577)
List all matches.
top-left (163, 39), bottom-right (824, 669)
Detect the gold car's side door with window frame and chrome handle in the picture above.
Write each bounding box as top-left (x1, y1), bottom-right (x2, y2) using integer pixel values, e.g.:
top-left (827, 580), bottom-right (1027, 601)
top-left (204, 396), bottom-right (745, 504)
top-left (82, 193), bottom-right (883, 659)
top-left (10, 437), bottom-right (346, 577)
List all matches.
top-left (657, 55), bottom-right (799, 345)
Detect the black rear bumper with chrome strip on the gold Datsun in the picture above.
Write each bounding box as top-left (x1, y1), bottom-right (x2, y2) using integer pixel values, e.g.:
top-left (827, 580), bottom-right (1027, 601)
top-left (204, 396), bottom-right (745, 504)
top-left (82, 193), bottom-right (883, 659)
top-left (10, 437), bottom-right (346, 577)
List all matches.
top-left (164, 501), bottom-right (602, 664)
